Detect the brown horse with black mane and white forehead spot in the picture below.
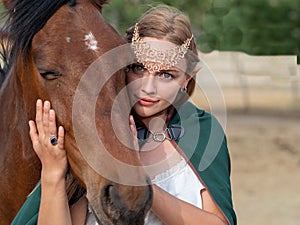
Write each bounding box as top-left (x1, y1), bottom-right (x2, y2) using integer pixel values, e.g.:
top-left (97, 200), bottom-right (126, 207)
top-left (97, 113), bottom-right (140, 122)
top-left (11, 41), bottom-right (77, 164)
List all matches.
top-left (0, 0), bottom-right (152, 225)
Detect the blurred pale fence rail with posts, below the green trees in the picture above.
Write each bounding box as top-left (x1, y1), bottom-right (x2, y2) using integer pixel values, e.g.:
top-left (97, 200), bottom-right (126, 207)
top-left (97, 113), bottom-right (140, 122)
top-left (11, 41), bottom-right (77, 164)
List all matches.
top-left (199, 51), bottom-right (300, 110)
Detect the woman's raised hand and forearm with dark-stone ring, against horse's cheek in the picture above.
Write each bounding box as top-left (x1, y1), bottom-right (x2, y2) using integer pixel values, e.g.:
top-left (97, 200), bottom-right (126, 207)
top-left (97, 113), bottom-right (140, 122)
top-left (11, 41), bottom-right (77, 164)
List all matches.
top-left (29, 99), bottom-right (72, 225)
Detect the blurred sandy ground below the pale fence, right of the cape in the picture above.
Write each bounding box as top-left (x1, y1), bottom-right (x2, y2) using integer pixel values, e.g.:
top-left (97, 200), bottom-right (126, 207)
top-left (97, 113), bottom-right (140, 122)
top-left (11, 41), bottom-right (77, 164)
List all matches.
top-left (226, 109), bottom-right (300, 225)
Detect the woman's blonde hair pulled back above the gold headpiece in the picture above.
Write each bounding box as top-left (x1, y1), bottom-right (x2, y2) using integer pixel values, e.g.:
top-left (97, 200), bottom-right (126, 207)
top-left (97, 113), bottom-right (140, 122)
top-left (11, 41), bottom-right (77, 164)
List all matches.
top-left (126, 5), bottom-right (199, 96)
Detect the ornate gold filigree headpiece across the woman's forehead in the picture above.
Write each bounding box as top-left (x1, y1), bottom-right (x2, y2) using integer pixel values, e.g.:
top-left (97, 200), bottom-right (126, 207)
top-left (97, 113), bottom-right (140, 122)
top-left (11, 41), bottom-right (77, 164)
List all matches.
top-left (132, 24), bottom-right (193, 72)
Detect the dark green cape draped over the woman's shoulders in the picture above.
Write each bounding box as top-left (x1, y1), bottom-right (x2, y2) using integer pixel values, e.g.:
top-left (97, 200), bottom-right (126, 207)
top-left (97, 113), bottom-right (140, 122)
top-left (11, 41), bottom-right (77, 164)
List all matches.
top-left (11, 102), bottom-right (237, 225)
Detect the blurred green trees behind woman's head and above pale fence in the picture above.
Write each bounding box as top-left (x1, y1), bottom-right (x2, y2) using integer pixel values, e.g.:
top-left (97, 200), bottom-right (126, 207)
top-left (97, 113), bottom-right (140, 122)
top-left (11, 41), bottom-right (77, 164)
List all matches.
top-left (104, 0), bottom-right (300, 63)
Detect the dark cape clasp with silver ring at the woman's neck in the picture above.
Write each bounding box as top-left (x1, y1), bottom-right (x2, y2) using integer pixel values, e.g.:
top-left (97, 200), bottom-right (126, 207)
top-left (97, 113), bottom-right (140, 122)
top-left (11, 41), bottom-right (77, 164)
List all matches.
top-left (137, 124), bottom-right (184, 144)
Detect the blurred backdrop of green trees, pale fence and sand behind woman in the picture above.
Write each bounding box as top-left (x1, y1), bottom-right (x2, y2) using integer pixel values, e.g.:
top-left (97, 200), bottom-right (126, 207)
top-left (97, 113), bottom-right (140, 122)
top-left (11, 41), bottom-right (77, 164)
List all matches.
top-left (2, 0), bottom-right (300, 225)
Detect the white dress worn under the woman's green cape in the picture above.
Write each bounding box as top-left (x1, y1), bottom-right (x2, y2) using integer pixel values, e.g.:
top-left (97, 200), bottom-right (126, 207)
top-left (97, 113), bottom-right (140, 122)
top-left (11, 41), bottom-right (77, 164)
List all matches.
top-left (86, 158), bottom-right (205, 225)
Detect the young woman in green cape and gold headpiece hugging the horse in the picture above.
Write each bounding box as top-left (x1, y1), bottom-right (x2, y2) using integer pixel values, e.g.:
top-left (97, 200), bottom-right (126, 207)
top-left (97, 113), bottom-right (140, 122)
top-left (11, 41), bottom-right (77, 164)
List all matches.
top-left (11, 3), bottom-right (236, 225)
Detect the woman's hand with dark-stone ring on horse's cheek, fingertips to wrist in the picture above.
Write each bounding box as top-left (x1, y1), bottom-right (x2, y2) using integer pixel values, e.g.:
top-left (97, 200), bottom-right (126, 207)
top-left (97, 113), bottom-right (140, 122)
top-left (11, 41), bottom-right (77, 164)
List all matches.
top-left (29, 99), bottom-right (68, 184)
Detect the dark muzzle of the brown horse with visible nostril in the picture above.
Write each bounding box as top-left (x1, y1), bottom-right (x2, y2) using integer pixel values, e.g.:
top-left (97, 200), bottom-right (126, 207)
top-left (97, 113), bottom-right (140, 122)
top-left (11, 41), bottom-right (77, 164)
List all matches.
top-left (88, 183), bottom-right (153, 225)
